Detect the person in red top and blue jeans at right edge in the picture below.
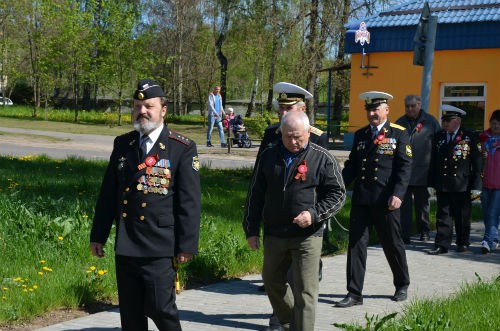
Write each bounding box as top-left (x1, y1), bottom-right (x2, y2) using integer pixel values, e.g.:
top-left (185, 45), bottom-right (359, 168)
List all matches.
top-left (479, 109), bottom-right (500, 254)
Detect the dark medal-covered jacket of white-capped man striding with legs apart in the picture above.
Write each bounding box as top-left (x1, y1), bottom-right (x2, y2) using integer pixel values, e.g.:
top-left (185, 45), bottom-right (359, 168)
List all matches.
top-left (342, 121), bottom-right (412, 207)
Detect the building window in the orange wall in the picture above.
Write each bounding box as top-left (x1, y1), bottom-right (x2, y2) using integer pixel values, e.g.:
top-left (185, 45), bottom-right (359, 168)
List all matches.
top-left (439, 83), bottom-right (486, 131)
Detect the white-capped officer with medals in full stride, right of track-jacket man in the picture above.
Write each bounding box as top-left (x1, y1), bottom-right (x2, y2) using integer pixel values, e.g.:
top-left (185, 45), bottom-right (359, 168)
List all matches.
top-left (336, 91), bottom-right (412, 308)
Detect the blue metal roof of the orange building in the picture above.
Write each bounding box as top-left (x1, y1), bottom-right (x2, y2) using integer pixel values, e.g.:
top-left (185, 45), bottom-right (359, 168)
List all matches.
top-left (345, 0), bottom-right (500, 53)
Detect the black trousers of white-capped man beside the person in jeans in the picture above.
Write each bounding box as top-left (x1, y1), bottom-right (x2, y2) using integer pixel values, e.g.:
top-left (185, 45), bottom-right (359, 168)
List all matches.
top-left (435, 191), bottom-right (472, 249)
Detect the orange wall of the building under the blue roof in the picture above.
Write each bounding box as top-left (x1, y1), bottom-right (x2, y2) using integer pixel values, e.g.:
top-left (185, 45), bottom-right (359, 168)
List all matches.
top-left (348, 49), bottom-right (500, 132)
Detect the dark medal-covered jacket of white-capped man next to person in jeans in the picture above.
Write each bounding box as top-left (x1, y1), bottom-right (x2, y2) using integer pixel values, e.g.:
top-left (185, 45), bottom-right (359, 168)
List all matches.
top-left (434, 127), bottom-right (483, 192)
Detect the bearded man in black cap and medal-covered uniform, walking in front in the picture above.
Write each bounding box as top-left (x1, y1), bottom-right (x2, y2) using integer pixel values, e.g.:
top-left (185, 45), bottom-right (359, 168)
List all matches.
top-left (90, 79), bottom-right (201, 331)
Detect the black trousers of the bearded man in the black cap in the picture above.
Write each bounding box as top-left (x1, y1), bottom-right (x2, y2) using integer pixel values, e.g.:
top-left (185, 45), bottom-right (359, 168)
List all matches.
top-left (116, 255), bottom-right (182, 331)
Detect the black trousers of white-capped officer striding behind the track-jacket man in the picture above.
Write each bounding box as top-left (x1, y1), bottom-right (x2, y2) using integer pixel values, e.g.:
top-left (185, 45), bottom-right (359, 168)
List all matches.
top-left (347, 205), bottom-right (410, 297)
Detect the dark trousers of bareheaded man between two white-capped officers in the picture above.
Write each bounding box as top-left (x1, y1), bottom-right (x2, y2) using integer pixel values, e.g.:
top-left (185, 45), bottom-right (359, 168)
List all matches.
top-left (401, 186), bottom-right (431, 240)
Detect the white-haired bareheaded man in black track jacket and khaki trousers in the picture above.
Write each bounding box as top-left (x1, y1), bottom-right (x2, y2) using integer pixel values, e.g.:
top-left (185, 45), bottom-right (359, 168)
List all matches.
top-left (243, 112), bottom-right (345, 331)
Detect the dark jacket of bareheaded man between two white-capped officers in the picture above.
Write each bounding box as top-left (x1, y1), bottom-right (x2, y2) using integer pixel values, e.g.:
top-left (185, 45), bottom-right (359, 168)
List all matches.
top-left (396, 110), bottom-right (441, 186)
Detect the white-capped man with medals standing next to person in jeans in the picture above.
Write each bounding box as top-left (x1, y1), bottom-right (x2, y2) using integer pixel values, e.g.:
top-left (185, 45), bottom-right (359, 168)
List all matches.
top-left (427, 105), bottom-right (482, 255)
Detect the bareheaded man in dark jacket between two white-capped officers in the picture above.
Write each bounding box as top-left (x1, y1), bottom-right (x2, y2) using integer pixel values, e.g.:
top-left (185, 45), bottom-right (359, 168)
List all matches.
top-left (396, 95), bottom-right (441, 244)
